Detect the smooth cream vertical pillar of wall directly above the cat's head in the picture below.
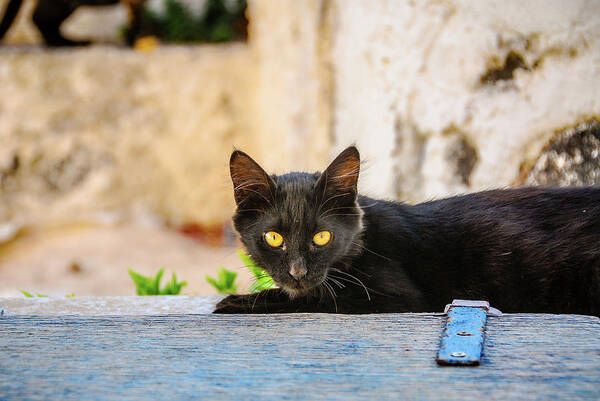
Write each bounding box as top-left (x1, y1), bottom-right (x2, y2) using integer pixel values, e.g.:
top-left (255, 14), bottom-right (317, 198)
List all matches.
top-left (247, 0), bottom-right (330, 173)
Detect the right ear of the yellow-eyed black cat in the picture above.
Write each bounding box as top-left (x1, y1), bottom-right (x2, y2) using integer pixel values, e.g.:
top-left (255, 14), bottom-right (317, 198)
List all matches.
top-left (317, 146), bottom-right (360, 203)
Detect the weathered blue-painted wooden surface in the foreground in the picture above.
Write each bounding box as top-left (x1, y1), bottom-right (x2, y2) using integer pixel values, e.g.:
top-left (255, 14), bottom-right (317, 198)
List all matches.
top-left (0, 314), bottom-right (600, 401)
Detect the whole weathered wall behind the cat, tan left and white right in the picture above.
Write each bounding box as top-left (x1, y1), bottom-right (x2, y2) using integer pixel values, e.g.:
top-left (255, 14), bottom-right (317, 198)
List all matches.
top-left (0, 0), bottom-right (600, 239)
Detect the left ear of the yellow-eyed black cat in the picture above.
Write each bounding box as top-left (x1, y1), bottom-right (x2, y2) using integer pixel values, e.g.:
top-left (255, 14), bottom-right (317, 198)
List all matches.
top-left (229, 150), bottom-right (275, 207)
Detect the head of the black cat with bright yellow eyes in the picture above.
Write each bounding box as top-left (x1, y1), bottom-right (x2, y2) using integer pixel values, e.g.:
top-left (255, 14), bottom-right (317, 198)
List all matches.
top-left (230, 146), bottom-right (362, 297)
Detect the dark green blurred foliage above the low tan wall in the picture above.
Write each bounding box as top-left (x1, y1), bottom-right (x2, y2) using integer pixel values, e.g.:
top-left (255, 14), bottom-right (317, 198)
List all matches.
top-left (135, 0), bottom-right (248, 43)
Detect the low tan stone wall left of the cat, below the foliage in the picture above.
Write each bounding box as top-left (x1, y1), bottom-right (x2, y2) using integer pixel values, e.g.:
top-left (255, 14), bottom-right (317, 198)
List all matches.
top-left (0, 45), bottom-right (260, 234)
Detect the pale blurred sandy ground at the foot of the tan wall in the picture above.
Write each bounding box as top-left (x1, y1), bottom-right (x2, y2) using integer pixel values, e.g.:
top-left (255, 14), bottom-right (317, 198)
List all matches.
top-left (0, 226), bottom-right (252, 297)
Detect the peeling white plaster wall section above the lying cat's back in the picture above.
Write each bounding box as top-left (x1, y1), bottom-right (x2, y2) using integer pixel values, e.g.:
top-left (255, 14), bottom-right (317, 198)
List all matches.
top-left (331, 0), bottom-right (600, 202)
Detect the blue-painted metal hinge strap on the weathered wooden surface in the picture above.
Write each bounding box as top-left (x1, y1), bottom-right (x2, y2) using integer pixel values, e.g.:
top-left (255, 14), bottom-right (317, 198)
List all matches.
top-left (436, 299), bottom-right (502, 366)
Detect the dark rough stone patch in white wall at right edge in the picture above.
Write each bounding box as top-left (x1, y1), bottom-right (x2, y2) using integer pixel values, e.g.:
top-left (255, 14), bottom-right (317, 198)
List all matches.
top-left (525, 120), bottom-right (600, 186)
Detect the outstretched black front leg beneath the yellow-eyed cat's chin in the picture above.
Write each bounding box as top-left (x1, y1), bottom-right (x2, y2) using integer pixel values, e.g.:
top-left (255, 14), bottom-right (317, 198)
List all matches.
top-left (213, 288), bottom-right (300, 313)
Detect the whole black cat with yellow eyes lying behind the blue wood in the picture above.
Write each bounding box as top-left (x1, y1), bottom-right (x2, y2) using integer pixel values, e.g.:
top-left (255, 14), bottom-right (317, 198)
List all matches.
top-left (215, 147), bottom-right (600, 315)
